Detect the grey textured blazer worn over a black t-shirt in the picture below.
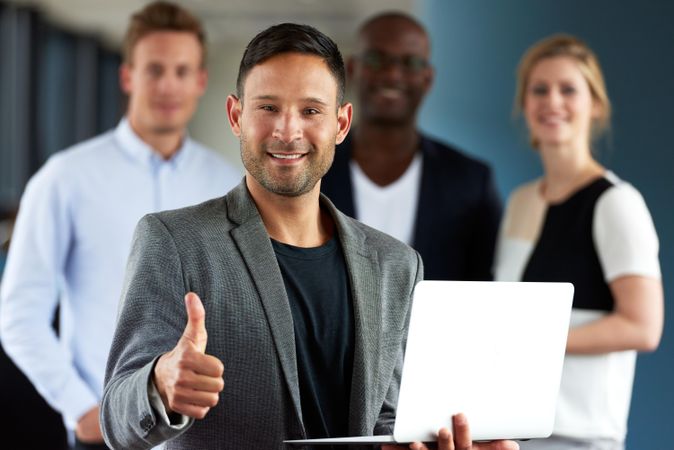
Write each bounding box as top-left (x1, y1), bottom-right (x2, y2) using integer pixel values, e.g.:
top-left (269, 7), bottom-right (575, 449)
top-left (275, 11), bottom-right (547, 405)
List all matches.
top-left (101, 182), bottom-right (423, 450)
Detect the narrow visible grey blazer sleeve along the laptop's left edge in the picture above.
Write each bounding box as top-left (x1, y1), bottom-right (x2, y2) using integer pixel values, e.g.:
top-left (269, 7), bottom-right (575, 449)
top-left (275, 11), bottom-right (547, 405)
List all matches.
top-left (373, 252), bottom-right (424, 435)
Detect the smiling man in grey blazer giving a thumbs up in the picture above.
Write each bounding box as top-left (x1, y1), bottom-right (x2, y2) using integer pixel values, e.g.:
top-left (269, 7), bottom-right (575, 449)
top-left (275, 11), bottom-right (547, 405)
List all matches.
top-left (101, 24), bottom-right (516, 450)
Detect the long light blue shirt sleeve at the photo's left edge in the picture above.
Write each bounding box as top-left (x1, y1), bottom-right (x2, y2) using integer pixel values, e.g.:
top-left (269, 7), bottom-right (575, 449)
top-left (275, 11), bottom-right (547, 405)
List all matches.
top-left (0, 160), bottom-right (98, 428)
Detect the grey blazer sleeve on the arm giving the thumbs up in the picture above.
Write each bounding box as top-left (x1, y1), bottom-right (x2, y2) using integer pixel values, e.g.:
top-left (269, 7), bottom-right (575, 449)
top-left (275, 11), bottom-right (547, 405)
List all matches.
top-left (100, 215), bottom-right (193, 449)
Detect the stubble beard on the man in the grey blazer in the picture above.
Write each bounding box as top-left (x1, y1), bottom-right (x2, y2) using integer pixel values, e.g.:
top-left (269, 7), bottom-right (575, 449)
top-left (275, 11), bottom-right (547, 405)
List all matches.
top-left (239, 134), bottom-right (335, 197)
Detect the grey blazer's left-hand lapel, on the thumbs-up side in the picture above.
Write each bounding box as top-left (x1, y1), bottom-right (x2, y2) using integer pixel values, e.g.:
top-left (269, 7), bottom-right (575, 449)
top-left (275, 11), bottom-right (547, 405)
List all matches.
top-left (227, 179), bottom-right (302, 423)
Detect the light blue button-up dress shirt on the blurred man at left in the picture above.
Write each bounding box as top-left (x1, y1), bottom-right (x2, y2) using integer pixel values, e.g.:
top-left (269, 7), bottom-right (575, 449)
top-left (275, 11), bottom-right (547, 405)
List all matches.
top-left (0, 119), bottom-right (242, 429)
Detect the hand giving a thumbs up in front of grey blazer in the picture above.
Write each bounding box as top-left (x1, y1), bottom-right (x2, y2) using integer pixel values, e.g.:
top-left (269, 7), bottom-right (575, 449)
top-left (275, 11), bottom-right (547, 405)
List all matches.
top-left (153, 292), bottom-right (224, 419)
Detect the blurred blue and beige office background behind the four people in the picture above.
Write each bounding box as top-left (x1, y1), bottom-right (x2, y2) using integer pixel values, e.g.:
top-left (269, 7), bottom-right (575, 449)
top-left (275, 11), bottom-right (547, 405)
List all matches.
top-left (0, 0), bottom-right (674, 449)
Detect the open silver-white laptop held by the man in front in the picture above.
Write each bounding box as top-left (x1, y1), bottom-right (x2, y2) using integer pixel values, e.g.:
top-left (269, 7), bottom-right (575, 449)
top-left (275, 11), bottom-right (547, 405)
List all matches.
top-left (284, 281), bottom-right (573, 445)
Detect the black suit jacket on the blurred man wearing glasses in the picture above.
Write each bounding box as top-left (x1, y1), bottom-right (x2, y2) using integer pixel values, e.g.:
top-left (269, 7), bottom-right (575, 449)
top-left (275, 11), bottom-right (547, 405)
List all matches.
top-left (321, 136), bottom-right (501, 280)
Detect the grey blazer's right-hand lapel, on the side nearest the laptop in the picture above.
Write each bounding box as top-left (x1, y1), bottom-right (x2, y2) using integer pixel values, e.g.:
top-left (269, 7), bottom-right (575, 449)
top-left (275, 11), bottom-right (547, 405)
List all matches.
top-left (321, 197), bottom-right (382, 435)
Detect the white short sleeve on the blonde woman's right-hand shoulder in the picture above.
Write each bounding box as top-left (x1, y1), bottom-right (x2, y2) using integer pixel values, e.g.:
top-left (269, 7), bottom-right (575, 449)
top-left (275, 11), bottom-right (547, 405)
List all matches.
top-left (592, 182), bottom-right (661, 282)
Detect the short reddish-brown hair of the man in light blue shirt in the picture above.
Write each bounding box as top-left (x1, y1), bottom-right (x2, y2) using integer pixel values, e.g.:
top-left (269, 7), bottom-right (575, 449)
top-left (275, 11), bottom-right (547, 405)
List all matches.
top-left (123, 1), bottom-right (206, 66)
